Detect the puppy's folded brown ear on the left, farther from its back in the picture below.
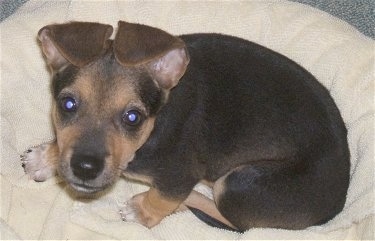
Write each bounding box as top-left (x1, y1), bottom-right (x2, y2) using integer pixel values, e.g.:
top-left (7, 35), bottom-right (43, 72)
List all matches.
top-left (38, 22), bottom-right (113, 71)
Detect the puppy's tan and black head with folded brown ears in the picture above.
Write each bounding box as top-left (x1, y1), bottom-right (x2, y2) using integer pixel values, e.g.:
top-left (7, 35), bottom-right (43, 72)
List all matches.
top-left (38, 22), bottom-right (189, 192)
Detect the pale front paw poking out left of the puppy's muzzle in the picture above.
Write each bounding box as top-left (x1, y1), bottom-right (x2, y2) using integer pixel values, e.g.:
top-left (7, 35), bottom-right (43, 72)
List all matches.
top-left (20, 143), bottom-right (57, 182)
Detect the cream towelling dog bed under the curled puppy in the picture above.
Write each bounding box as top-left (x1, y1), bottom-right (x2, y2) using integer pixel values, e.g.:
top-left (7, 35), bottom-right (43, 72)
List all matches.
top-left (0, 0), bottom-right (375, 240)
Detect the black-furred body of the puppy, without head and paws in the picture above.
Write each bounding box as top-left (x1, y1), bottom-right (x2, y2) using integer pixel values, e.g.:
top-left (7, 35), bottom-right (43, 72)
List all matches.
top-left (127, 34), bottom-right (350, 230)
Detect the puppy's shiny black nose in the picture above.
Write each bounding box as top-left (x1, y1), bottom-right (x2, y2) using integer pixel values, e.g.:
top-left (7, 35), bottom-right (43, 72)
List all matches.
top-left (70, 155), bottom-right (104, 180)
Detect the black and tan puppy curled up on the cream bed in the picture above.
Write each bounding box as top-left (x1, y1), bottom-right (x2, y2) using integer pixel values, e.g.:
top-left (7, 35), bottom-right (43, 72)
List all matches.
top-left (22, 22), bottom-right (350, 230)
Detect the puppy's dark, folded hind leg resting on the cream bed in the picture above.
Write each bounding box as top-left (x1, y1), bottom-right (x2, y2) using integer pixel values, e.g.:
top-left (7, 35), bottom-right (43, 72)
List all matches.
top-left (214, 160), bottom-right (327, 230)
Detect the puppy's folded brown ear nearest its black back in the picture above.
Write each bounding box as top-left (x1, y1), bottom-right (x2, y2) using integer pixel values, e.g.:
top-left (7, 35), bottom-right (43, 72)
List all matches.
top-left (114, 21), bottom-right (189, 90)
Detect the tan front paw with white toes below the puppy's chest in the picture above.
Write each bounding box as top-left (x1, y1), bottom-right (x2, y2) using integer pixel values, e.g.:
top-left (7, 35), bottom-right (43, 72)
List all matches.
top-left (119, 193), bottom-right (164, 228)
